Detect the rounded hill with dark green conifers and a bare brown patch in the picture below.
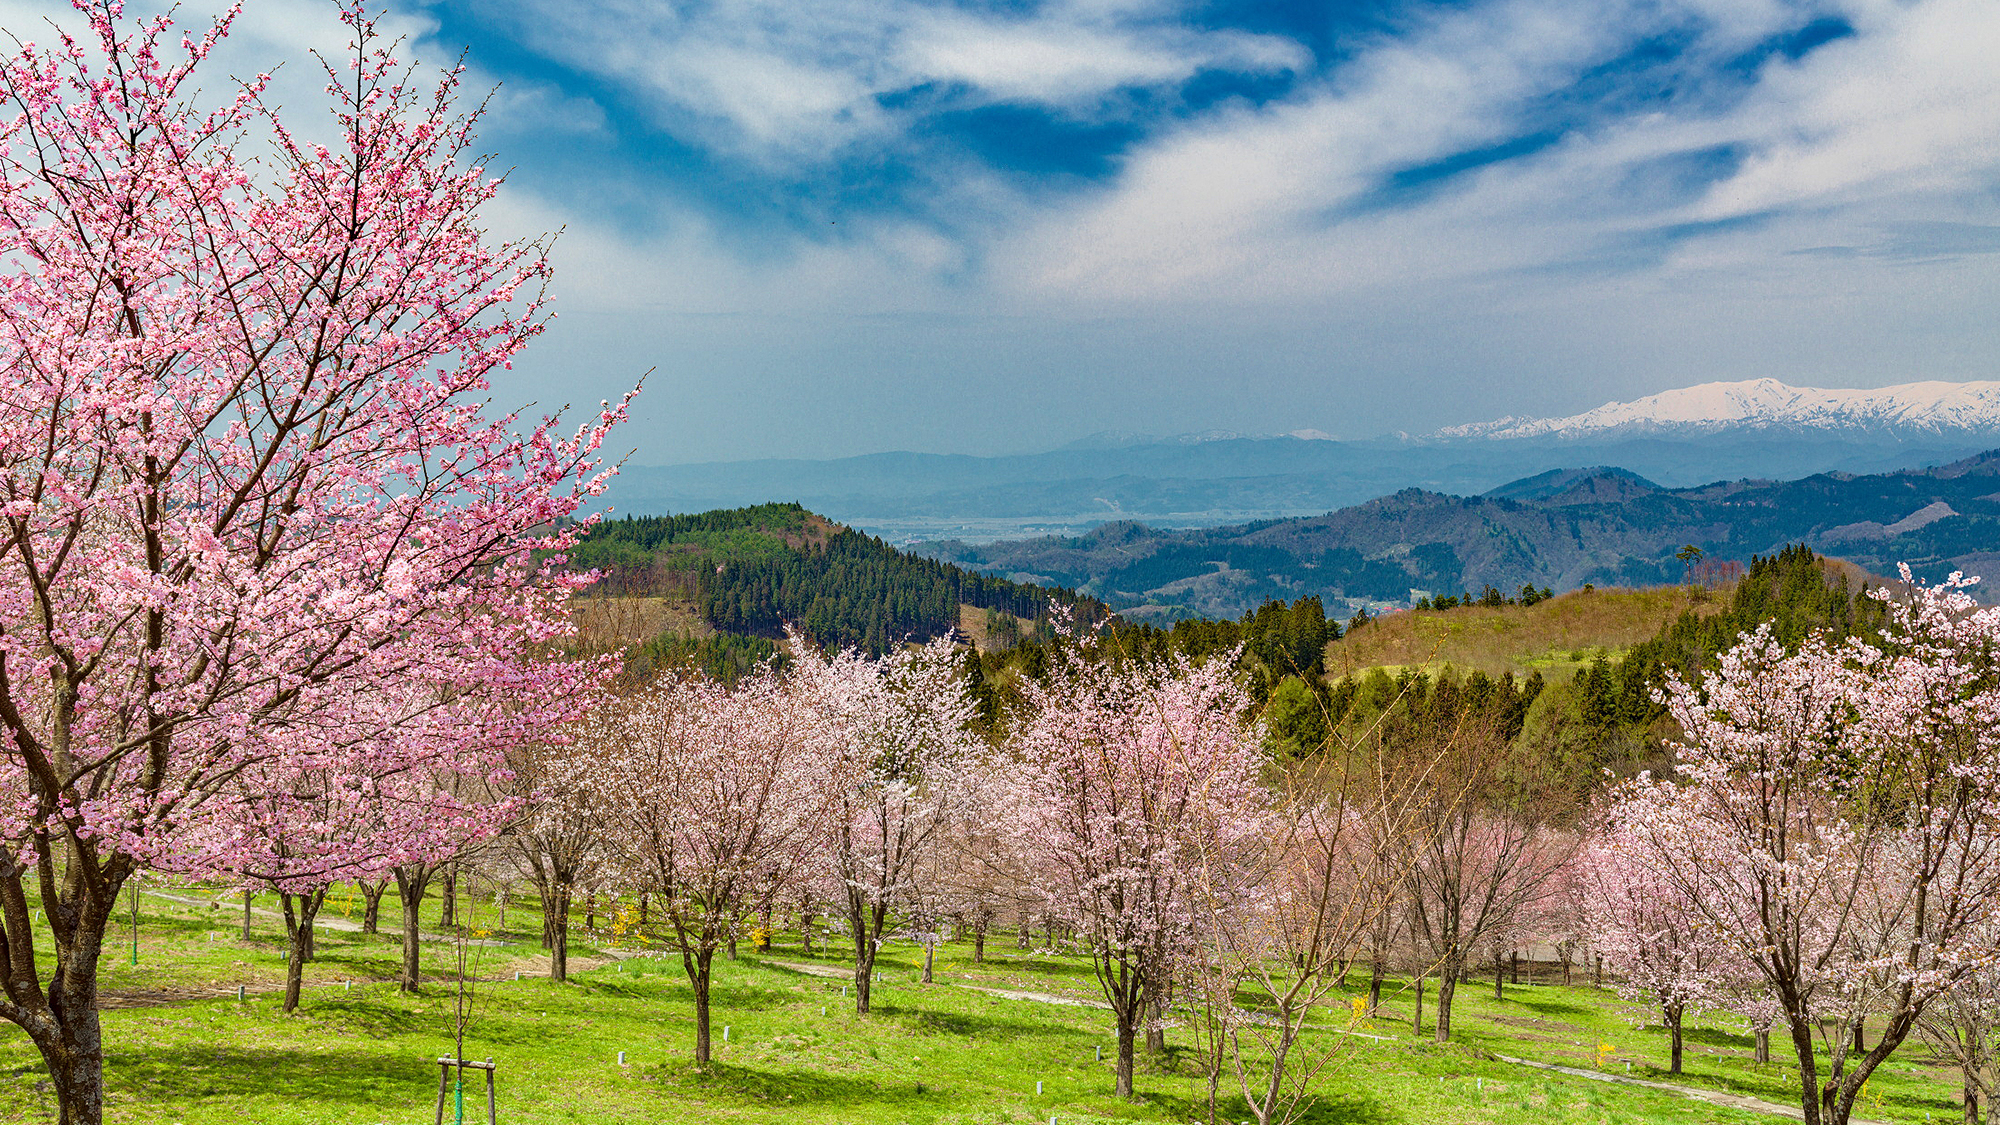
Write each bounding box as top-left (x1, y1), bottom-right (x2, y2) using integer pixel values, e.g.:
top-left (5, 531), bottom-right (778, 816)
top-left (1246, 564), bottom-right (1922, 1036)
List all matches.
top-left (570, 504), bottom-right (1106, 653)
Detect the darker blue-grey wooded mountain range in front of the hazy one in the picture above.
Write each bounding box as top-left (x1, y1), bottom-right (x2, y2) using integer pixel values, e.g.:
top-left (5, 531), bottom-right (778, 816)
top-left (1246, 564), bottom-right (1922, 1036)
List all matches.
top-left (920, 450), bottom-right (2000, 619)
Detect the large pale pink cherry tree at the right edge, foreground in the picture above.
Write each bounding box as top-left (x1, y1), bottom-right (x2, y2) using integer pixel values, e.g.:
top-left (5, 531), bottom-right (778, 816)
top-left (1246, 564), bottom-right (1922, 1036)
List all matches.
top-left (1612, 569), bottom-right (2000, 1125)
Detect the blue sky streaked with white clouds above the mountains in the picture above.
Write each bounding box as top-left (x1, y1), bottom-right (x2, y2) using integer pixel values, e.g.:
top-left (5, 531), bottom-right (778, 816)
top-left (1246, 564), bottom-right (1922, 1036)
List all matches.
top-left (19, 0), bottom-right (2000, 462)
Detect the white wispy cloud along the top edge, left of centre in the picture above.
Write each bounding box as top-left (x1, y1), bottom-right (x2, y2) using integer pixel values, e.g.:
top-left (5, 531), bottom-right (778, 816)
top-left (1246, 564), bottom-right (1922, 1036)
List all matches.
top-left (454, 0), bottom-right (1306, 164)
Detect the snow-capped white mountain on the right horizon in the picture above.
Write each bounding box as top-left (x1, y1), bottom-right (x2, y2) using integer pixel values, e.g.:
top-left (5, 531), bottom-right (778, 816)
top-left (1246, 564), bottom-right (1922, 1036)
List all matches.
top-left (1434, 378), bottom-right (2000, 438)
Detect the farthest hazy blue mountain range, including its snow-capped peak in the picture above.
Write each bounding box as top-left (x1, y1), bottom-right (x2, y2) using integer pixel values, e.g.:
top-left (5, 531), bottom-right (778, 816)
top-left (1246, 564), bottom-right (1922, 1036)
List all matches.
top-left (608, 378), bottom-right (2000, 542)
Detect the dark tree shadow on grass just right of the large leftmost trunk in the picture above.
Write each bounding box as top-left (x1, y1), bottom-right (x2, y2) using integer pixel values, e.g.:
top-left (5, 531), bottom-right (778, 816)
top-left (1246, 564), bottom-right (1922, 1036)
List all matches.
top-left (106, 1045), bottom-right (426, 1105)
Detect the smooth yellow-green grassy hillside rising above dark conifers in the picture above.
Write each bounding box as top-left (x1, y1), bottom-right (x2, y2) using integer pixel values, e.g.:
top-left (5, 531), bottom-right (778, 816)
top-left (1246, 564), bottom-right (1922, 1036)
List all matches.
top-left (1326, 587), bottom-right (1726, 681)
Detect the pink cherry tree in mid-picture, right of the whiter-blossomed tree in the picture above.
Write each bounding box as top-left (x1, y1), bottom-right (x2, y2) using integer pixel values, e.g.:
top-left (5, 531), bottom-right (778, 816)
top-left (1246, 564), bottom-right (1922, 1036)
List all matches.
top-left (1002, 639), bottom-right (1264, 1097)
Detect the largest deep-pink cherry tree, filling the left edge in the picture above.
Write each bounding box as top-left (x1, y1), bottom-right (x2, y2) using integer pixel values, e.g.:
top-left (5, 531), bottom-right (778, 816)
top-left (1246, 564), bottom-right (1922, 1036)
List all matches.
top-left (0, 0), bottom-right (620, 1125)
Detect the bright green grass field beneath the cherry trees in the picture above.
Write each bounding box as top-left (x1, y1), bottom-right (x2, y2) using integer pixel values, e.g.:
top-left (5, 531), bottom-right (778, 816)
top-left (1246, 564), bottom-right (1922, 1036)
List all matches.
top-left (0, 897), bottom-right (1958, 1125)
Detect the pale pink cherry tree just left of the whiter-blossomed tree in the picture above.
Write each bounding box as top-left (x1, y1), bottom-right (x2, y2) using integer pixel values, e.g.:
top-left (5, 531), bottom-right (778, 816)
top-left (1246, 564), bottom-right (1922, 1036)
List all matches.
top-left (576, 667), bottom-right (834, 1065)
